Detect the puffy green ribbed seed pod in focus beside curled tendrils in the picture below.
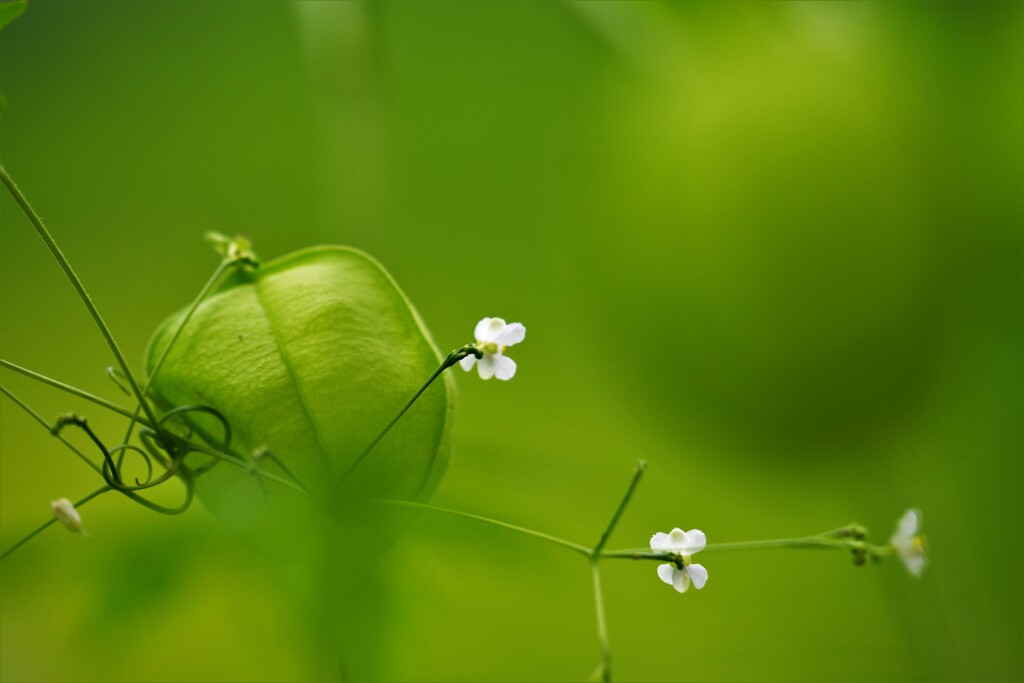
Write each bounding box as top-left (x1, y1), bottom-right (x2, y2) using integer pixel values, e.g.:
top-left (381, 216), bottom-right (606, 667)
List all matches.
top-left (146, 247), bottom-right (455, 512)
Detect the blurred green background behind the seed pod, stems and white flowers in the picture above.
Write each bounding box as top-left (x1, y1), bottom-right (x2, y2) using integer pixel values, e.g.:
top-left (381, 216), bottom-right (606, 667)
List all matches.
top-left (0, 2), bottom-right (1024, 681)
